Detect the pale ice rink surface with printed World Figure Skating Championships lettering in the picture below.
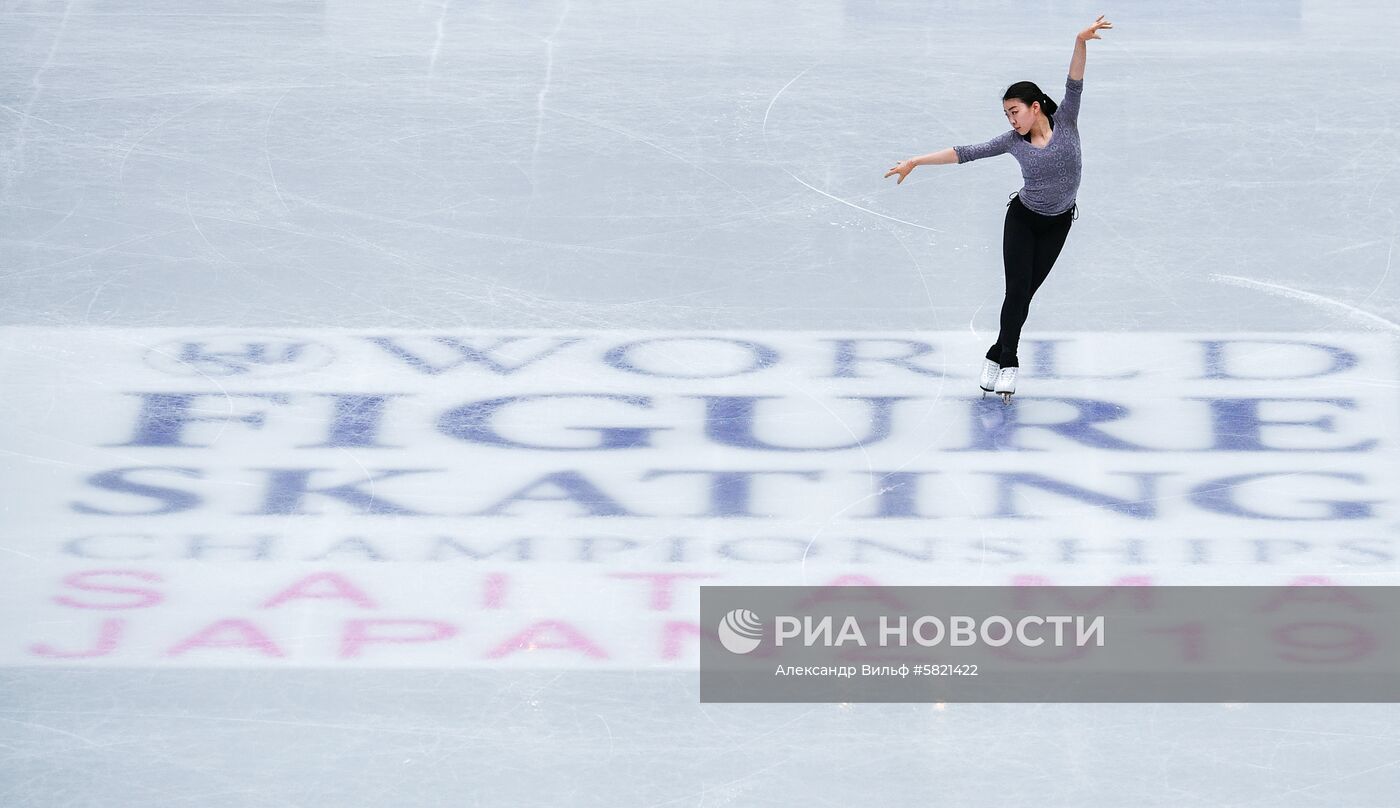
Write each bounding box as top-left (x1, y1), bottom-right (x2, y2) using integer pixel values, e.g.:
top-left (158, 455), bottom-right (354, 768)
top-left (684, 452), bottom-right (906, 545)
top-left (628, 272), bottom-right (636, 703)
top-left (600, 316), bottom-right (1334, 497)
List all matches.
top-left (0, 0), bottom-right (1400, 808)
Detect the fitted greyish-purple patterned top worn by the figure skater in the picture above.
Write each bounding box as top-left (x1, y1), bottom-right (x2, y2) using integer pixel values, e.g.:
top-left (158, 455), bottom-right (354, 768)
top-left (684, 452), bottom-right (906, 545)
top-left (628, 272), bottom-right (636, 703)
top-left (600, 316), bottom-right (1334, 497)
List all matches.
top-left (953, 78), bottom-right (1084, 216)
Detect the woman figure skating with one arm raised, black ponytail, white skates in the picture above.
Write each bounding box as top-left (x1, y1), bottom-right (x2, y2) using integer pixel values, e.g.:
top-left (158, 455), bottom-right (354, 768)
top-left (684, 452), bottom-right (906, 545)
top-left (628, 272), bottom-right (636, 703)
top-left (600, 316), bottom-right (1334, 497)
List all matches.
top-left (885, 15), bottom-right (1113, 402)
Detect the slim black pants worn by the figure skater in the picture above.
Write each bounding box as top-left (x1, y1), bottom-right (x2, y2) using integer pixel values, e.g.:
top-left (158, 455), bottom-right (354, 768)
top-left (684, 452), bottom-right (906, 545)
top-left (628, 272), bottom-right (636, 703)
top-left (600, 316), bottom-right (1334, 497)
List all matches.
top-left (987, 195), bottom-right (1078, 367)
